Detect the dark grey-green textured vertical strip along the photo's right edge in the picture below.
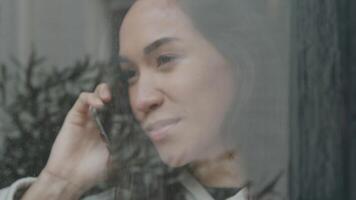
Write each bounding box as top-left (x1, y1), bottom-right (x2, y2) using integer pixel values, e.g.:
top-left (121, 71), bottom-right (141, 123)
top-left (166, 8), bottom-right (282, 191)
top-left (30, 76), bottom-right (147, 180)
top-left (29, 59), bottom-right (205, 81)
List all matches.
top-left (289, 0), bottom-right (356, 200)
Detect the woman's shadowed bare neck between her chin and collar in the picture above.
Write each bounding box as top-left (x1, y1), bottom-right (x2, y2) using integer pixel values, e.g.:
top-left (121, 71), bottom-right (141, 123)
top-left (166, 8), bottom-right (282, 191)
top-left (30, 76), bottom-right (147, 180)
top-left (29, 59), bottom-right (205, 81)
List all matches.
top-left (191, 151), bottom-right (244, 188)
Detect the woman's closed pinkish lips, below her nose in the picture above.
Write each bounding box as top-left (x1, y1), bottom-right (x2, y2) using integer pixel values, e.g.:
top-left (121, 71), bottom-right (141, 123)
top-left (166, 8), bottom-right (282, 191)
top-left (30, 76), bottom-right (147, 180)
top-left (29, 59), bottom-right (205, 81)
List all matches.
top-left (144, 118), bottom-right (180, 141)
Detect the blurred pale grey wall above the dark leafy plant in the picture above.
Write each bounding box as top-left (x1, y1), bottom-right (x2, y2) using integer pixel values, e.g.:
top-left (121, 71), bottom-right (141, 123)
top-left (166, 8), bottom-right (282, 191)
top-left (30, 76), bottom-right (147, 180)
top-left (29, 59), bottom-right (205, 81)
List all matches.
top-left (0, 0), bottom-right (129, 66)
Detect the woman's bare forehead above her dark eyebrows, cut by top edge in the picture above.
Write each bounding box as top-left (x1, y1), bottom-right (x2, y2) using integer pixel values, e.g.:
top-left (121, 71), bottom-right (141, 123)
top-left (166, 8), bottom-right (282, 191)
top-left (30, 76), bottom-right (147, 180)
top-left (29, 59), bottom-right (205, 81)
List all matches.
top-left (120, 0), bottom-right (195, 54)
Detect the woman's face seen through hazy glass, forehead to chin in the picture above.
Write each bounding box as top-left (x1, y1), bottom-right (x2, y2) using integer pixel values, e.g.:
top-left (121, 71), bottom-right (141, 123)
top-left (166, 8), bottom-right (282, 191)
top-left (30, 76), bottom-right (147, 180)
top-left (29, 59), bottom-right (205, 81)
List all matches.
top-left (120, 0), bottom-right (235, 166)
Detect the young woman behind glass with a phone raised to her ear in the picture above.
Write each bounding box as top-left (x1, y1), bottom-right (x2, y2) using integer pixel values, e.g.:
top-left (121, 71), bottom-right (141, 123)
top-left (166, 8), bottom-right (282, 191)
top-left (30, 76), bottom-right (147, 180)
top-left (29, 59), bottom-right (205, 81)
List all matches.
top-left (2, 0), bottom-right (286, 200)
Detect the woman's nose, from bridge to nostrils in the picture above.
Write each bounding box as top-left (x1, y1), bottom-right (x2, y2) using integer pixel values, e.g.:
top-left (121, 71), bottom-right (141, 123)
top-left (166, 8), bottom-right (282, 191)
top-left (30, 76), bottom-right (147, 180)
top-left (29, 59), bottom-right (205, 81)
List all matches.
top-left (130, 77), bottom-right (164, 120)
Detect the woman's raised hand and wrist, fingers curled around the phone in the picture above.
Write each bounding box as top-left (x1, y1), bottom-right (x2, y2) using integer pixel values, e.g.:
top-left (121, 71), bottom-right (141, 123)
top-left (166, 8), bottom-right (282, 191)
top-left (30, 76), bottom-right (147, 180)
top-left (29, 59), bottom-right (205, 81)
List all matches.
top-left (23, 84), bottom-right (112, 200)
